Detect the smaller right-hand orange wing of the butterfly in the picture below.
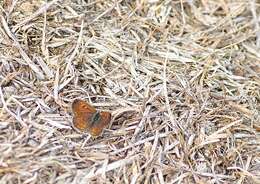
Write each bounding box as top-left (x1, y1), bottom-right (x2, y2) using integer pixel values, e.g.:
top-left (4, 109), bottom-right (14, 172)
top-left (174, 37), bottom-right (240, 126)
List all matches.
top-left (89, 112), bottom-right (111, 136)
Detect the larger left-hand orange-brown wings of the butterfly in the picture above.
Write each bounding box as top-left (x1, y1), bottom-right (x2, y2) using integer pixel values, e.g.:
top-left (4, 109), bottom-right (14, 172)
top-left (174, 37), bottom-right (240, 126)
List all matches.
top-left (72, 99), bottom-right (96, 131)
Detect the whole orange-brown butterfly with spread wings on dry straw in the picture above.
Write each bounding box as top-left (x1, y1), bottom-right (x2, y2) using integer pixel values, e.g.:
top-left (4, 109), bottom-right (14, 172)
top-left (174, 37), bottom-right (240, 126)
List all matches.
top-left (72, 99), bottom-right (111, 137)
